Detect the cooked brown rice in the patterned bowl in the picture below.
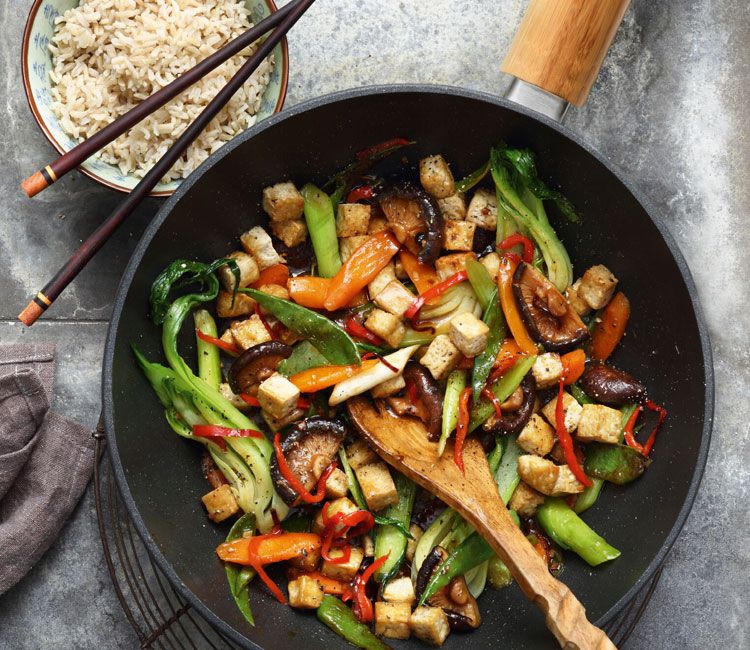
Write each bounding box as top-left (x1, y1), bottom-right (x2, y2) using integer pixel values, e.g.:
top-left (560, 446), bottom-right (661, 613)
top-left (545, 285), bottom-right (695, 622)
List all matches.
top-left (50, 0), bottom-right (274, 181)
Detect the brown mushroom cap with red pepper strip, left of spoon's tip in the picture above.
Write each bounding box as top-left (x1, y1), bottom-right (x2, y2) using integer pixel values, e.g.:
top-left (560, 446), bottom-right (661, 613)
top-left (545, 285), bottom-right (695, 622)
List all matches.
top-left (271, 416), bottom-right (346, 506)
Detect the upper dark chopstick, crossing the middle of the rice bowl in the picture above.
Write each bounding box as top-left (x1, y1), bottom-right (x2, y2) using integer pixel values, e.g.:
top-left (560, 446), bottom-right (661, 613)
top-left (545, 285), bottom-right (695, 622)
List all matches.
top-left (21, 0), bottom-right (301, 197)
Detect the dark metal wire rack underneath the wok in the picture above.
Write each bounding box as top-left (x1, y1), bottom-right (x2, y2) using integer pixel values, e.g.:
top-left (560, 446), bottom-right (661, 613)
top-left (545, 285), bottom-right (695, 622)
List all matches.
top-left (94, 426), bottom-right (663, 650)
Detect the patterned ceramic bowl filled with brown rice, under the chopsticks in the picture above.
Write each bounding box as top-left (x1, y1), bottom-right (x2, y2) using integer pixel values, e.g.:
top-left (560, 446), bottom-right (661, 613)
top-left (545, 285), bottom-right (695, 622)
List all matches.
top-left (22, 0), bottom-right (289, 196)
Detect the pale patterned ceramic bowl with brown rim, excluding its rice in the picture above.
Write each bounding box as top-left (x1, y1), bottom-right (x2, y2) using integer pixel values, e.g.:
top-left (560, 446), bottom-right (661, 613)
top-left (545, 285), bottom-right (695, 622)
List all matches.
top-left (22, 0), bottom-right (289, 196)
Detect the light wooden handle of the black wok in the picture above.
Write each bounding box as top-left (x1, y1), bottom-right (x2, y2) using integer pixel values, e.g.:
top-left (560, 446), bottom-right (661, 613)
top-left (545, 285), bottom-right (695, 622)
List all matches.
top-left (502, 0), bottom-right (630, 106)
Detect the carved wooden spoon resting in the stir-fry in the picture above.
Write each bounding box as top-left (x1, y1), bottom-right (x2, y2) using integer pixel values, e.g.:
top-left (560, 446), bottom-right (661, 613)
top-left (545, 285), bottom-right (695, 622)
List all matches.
top-left (347, 397), bottom-right (616, 650)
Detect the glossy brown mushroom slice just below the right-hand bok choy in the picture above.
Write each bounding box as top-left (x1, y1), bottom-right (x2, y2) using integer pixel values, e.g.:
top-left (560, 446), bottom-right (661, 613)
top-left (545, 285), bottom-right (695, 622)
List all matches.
top-left (513, 262), bottom-right (589, 352)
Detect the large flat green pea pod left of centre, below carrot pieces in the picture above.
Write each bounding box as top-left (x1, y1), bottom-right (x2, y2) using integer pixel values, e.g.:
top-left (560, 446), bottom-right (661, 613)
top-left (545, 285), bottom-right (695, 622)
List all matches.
top-left (240, 289), bottom-right (361, 365)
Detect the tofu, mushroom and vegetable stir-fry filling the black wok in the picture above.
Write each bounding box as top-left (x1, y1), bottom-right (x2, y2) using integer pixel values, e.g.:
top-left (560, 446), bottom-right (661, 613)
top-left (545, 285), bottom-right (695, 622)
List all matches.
top-left (134, 140), bottom-right (666, 648)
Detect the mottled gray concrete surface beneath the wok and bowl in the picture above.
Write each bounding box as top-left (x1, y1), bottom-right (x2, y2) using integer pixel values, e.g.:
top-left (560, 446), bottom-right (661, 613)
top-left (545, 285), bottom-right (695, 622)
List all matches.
top-left (0, 0), bottom-right (750, 650)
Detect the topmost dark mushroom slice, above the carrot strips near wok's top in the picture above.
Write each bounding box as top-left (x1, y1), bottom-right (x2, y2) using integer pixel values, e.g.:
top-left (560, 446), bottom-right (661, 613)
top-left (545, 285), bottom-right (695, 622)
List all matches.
top-left (378, 183), bottom-right (443, 264)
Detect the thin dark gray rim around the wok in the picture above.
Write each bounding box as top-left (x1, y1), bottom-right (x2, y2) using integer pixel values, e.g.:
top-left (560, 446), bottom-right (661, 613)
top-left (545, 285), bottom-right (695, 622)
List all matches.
top-left (102, 84), bottom-right (715, 650)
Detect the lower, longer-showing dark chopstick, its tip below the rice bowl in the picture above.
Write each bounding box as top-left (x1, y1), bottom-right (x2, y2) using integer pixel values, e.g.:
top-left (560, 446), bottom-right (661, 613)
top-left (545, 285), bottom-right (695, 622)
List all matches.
top-left (18, 0), bottom-right (315, 326)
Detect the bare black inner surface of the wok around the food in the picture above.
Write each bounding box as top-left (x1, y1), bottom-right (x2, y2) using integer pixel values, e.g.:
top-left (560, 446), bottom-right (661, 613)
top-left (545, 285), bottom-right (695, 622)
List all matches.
top-left (109, 91), bottom-right (706, 649)
